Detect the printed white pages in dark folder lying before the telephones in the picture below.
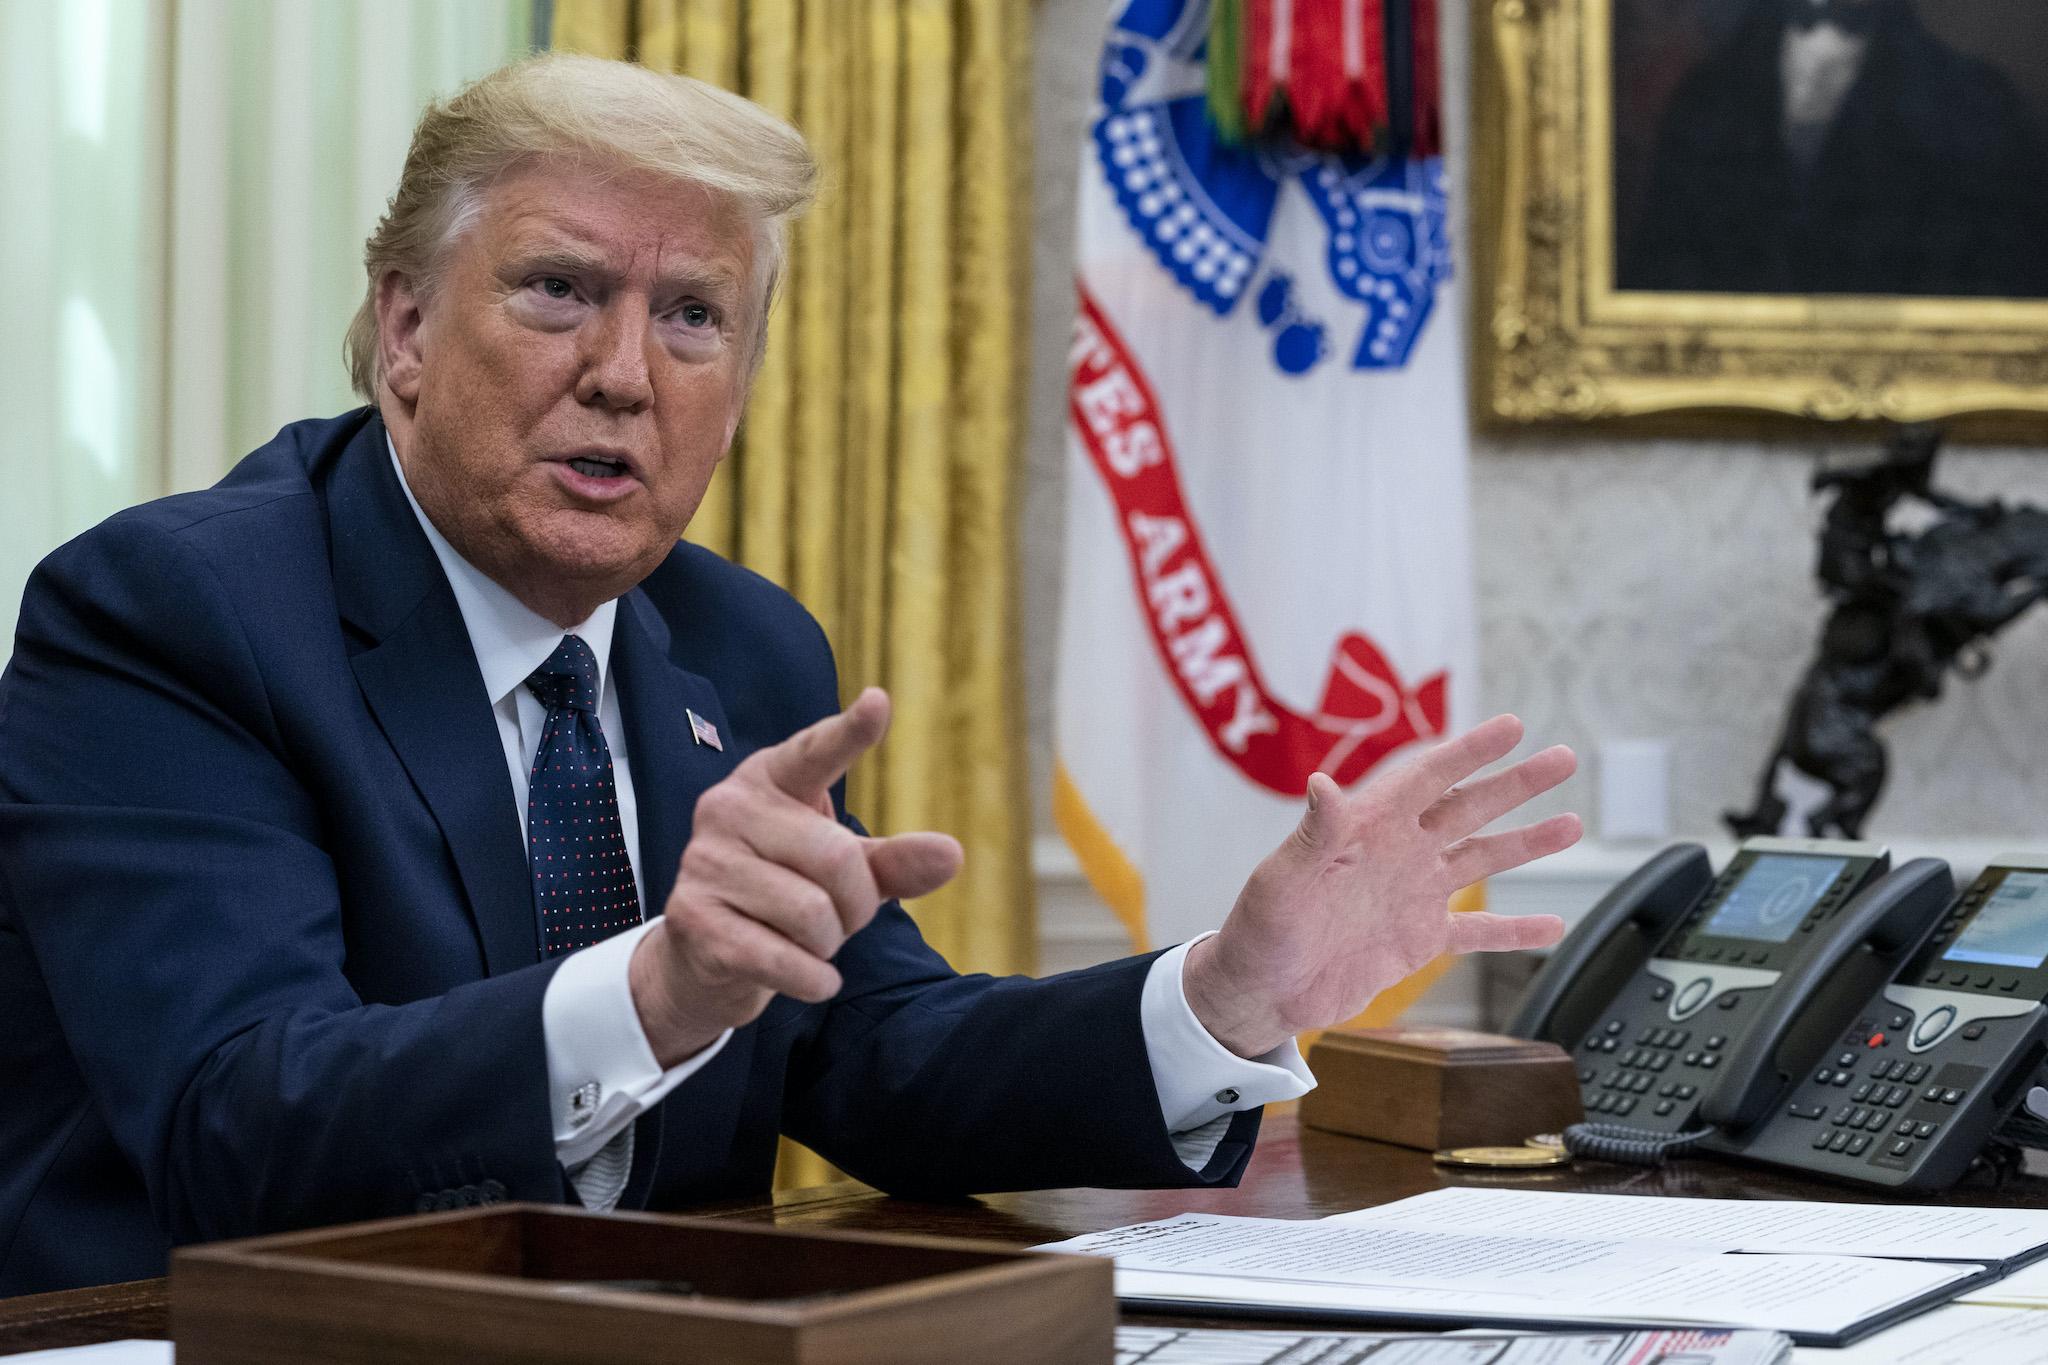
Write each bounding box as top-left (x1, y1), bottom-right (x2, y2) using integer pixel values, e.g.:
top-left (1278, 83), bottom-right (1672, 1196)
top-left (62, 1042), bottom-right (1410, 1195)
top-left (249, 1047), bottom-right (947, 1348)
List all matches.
top-left (1047, 1189), bottom-right (2048, 1347)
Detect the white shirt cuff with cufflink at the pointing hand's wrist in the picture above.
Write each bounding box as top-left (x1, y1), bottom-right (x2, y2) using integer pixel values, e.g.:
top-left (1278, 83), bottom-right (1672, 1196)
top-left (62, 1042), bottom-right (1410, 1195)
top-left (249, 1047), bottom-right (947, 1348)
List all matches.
top-left (541, 919), bottom-right (733, 1166)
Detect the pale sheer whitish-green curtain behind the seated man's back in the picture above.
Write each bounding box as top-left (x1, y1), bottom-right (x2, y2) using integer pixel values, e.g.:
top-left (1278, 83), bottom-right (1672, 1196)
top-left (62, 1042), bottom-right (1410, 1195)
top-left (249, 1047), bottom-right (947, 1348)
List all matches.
top-left (0, 0), bottom-right (532, 663)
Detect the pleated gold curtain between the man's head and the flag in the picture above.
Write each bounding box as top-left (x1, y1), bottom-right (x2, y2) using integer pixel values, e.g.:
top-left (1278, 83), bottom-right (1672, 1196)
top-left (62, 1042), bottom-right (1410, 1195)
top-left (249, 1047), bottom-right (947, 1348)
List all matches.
top-left (553, 0), bottom-right (1036, 1183)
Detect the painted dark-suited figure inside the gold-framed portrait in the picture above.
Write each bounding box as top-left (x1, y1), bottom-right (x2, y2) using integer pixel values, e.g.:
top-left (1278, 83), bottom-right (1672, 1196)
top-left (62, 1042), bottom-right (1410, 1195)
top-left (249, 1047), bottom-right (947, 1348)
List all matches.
top-left (1616, 0), bottom-right (2048, 299)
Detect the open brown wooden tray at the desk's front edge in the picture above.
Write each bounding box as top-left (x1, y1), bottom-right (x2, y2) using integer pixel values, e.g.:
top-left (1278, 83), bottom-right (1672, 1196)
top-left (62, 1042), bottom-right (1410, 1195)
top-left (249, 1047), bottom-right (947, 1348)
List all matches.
top-left (170, 1203), bottom-right (1116, 1365)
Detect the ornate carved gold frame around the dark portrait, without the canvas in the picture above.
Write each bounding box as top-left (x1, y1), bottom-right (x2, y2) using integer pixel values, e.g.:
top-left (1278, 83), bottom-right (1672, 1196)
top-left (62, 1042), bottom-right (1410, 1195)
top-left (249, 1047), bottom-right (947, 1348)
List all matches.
top-left (1470, 0), bottom-right (2048, 440)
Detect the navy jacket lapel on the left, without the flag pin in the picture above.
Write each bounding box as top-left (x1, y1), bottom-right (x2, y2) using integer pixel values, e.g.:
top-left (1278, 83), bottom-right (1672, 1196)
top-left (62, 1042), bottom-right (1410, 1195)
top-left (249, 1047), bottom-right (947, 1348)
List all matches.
top-left (328, 422), bottom-right (541, 976)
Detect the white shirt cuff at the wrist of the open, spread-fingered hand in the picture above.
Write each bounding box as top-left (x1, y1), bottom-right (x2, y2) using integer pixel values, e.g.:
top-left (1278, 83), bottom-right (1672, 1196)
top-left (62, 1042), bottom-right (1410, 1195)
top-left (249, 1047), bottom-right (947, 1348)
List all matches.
top-left (1139, 933), bottom-right (1315, 1146)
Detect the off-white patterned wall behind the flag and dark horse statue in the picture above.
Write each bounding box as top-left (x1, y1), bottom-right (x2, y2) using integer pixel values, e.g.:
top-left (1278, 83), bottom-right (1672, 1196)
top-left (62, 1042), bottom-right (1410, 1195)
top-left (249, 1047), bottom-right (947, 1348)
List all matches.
top-left (1024, 0), bottom-right (2048, 1019)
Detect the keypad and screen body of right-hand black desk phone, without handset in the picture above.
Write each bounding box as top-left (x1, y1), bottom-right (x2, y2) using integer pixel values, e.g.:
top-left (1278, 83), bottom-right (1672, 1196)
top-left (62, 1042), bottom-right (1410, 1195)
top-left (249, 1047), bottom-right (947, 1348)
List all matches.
top-left (1704, 853), bottom-right (2048, 1189)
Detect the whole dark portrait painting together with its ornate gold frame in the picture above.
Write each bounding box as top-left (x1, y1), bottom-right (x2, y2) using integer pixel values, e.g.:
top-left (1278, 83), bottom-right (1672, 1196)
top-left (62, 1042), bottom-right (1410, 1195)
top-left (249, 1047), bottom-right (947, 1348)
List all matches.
top-left (1473, 0), bottom-right (2048, 438)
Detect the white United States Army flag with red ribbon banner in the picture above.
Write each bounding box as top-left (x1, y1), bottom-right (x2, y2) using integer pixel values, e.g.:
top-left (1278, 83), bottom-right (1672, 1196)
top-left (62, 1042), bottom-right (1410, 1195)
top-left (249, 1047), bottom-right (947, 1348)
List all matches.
top-left (1055, 0), bottom-right (1475, 1005)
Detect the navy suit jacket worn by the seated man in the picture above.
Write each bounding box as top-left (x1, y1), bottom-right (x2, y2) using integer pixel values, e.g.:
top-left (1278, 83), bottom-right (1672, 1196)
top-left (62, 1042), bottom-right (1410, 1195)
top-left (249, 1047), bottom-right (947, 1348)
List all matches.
top-left (0, 409), bottom-right (1257, 1295)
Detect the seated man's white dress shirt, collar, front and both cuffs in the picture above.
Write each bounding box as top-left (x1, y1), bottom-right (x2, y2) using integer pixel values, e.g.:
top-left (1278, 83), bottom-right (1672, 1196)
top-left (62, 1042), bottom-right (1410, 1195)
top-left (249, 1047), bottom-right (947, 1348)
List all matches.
top-left (385, 436), bottom-right (1315, 1209)
